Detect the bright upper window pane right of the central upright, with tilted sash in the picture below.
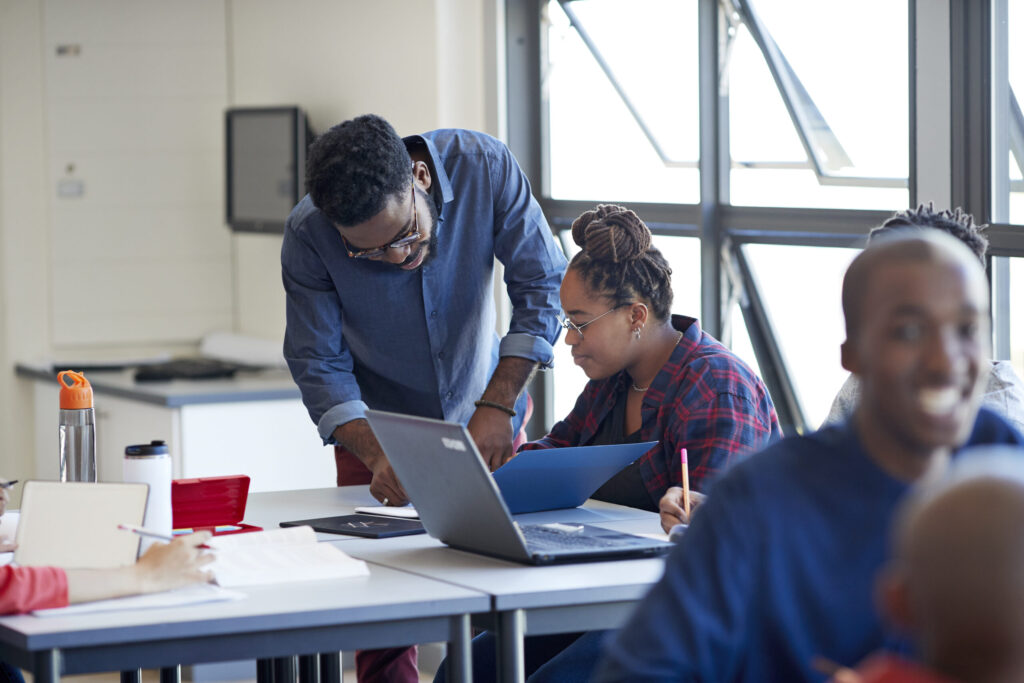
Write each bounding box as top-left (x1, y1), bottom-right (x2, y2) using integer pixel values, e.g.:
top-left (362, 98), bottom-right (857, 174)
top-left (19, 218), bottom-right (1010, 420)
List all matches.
top-left (724, 0), bottom-right (909, 209)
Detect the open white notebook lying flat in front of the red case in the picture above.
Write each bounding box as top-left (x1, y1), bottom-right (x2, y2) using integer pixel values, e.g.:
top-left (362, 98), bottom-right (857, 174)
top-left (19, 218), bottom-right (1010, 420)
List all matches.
top-left (207, 526), bottom-right (370, 588)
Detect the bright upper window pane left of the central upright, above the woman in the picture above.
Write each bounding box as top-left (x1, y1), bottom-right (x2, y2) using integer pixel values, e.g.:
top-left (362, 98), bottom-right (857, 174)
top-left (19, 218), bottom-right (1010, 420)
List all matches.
top-left (545, 0), bottom-right (699, 204)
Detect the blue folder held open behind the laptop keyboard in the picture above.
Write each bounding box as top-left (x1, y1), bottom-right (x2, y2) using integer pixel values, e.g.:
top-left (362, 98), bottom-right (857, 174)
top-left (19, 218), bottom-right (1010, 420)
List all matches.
top-left (495, 441), bottom-right (657, 515)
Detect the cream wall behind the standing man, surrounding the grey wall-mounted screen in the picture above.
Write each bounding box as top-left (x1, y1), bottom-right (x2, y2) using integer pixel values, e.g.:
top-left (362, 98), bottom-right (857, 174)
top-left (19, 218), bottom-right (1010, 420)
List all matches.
top-left (0, 0), bottom-right (503, 501)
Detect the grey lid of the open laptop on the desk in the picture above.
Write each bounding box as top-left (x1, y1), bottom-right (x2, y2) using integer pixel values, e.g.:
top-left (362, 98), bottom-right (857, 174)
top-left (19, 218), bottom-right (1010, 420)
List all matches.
top-left (367, 411), bottom-right (530, 561)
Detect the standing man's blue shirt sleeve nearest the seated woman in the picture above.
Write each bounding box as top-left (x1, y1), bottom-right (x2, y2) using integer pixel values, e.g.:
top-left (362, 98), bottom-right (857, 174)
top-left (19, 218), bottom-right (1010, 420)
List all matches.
top-left (488, 145), bottom-right (566, 367)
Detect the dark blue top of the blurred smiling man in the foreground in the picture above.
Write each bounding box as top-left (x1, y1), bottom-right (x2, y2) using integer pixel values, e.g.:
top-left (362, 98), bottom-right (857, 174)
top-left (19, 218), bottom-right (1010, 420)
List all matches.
top-left (597, 410), bottom-right (1024, 683)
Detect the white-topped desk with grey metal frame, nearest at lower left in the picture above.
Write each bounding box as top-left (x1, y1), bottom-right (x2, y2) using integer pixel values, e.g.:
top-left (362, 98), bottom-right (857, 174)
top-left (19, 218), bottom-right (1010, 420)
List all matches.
top-left (0, 565), bottom-right (490, 683)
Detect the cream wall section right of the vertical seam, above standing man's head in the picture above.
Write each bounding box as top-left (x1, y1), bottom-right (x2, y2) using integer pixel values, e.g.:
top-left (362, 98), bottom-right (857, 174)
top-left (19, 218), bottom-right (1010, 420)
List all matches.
top-left (227, 0), bottom-right (499, 339)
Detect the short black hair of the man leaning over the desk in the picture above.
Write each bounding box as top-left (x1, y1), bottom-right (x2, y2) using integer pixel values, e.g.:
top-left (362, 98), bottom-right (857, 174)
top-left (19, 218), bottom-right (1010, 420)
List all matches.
top-left (306, 114), bottom-right (413, 227)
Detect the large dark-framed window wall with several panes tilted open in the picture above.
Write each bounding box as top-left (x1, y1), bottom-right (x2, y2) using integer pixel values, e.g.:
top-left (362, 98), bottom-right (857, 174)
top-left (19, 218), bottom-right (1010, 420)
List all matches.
top-left (520, 0), bottom-right (1024, 431)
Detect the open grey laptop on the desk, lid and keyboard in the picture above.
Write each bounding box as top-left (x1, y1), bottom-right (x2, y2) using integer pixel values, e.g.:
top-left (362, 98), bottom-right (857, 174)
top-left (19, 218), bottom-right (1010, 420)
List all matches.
top-left (367, 411), bottom-right (672, 564)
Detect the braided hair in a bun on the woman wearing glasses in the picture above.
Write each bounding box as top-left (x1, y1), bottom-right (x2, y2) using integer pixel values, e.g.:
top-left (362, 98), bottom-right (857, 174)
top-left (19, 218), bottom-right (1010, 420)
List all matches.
top-left (569, 204), bottom-right (672, 321)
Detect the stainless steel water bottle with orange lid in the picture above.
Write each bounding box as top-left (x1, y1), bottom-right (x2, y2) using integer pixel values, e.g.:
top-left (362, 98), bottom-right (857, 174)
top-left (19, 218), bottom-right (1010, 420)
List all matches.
top-left (57, 370), bottom-right (96, 481)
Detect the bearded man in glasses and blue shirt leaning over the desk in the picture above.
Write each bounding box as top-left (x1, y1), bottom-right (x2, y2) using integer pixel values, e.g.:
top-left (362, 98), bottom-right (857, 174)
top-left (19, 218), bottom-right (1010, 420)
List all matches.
top-left (281, 115), bottom-right (565, 504)
